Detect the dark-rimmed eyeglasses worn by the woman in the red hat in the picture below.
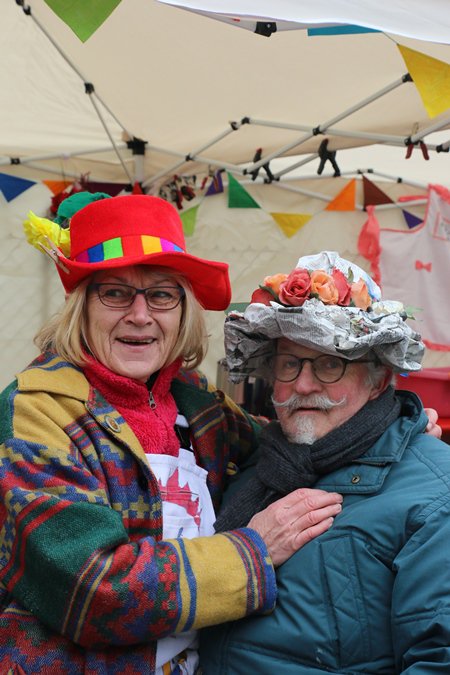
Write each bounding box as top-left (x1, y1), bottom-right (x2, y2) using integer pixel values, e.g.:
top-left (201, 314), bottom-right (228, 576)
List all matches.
top-left (89, 284), bottom-right (185, 311)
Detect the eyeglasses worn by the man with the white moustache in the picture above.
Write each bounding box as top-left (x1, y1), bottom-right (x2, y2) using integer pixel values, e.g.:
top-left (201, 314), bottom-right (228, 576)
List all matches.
top-left (269, 354), bottom-right (374, 384)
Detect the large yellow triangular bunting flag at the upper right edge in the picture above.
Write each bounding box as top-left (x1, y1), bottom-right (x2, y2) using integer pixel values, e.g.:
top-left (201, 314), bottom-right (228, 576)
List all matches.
top-left (397, 45), bottom-right (450, 117)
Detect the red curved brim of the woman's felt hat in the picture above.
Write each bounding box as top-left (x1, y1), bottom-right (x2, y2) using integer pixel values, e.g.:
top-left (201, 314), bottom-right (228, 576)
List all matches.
top-left (57, 251), bottom-right (231, 311)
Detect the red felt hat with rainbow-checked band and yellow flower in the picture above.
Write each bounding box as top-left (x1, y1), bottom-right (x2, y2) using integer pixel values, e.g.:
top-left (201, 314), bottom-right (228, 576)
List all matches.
top-left (24, 193), bottom-right (231, 310)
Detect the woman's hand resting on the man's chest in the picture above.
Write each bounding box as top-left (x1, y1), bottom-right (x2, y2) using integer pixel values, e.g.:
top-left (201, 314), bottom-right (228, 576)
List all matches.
top-left (248, 488), bottom-right (342, 567)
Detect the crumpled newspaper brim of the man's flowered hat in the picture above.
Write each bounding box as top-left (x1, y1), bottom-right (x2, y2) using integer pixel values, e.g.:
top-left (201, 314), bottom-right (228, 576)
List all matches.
top-left (224, 299), bottom-right (424, 382)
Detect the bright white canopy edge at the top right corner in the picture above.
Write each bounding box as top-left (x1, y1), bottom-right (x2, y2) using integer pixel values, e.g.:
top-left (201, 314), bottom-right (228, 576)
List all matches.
top-left (159, 0), bottom-right (450, 44)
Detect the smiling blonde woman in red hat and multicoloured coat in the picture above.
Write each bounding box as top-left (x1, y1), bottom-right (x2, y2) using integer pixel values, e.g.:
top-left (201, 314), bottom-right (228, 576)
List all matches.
top-left (0, 195), bottom-right (341, 675)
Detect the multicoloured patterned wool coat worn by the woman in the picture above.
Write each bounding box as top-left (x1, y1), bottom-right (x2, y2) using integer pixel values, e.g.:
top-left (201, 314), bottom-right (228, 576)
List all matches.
top-left (0, 354), bottom-right (276, 675)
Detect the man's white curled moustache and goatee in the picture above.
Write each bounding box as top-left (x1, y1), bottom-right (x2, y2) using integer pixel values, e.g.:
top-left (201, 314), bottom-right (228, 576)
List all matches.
top-left (272, 394), bottom-right (347, 445)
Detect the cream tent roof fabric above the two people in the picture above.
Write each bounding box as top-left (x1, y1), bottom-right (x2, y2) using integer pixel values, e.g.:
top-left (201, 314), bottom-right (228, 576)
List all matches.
top-left (0, 0), bottom-right (450, 189)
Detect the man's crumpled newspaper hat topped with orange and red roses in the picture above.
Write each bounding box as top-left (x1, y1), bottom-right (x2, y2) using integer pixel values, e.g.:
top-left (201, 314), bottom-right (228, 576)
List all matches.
top-left (225, 251), bottom-right (424, 382)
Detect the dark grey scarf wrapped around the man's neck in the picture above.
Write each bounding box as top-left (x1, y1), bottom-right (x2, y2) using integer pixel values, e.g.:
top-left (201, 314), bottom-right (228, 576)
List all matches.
top-left (214, 387), bottom-right (400, 532)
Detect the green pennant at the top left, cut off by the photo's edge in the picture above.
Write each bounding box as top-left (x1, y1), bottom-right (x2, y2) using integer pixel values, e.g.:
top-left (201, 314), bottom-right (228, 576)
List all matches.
top-left (44, 0), bottom-right (121, 42)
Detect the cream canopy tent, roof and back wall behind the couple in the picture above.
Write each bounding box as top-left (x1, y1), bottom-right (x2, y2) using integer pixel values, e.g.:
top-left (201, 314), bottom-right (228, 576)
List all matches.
top-left (0, 0), bottom-right (450, 394)
